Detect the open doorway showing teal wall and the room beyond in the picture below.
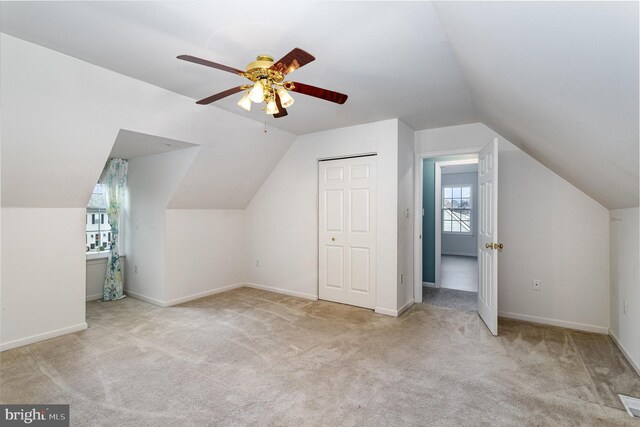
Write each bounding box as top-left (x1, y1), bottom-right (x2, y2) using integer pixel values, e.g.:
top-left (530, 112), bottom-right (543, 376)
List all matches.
top-left (422, 155), bottom-right (478, 311)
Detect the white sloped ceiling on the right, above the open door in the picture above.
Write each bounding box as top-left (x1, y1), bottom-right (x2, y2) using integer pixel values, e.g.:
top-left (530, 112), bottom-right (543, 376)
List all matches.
top-left (435, 2), bottom-right (639, 209)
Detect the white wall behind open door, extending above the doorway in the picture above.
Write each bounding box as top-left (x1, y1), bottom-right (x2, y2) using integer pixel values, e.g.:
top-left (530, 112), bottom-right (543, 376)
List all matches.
top-left (416, 123), bottom-right (609, 333)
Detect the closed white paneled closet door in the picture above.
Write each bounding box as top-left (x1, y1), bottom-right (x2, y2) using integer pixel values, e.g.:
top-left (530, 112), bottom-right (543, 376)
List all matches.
top-left (318, 156), bottom-right (376, 308)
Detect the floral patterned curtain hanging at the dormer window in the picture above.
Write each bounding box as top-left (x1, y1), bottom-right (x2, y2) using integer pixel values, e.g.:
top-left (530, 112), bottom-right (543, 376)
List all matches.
top-left (100, 158), bottom-right (128, 301)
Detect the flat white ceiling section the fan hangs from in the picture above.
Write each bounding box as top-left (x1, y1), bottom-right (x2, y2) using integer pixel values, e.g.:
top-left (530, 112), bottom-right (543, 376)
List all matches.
top-left (0, 1), bottom-right (477, 135)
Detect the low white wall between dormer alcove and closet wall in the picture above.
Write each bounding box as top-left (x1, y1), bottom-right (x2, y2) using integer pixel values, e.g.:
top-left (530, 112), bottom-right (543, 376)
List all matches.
top-left (165, 209), bottom-right (246, 305)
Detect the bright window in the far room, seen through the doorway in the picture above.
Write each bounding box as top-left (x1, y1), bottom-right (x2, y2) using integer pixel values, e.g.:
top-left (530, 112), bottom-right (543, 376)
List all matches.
top-left (442, 185), bottom-right (472, 234)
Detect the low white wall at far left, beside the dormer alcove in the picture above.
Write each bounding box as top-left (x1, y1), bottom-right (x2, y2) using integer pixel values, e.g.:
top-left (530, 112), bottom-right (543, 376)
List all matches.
top-left (0, 208), bottom-right (87, 350)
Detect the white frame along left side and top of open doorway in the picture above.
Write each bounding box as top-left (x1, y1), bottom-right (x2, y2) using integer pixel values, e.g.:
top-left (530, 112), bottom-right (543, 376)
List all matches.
top-left (413, 145), bottom-right (484, 303)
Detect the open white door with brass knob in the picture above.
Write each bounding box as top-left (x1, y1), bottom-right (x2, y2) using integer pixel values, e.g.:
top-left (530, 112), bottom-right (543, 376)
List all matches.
top-left (478, 138), bottom-right (502, 335)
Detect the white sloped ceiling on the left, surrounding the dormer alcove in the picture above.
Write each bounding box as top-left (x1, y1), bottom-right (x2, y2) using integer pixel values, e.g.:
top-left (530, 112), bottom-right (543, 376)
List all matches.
top-left (0, 34), bottom-right (295, 209)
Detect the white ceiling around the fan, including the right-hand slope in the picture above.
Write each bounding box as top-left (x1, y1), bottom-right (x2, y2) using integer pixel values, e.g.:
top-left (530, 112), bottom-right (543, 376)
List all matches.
top-left (0, 1), bottom-right (639, 208)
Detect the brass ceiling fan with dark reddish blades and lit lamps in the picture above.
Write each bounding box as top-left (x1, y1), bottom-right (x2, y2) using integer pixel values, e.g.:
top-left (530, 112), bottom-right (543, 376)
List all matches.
top-left (178, 48), bottom-right (347, 118)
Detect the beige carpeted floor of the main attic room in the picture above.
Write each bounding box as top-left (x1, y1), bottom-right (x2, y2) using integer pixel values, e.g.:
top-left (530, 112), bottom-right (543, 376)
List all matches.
top-left (0, 288), bottom-right (640, 427)
